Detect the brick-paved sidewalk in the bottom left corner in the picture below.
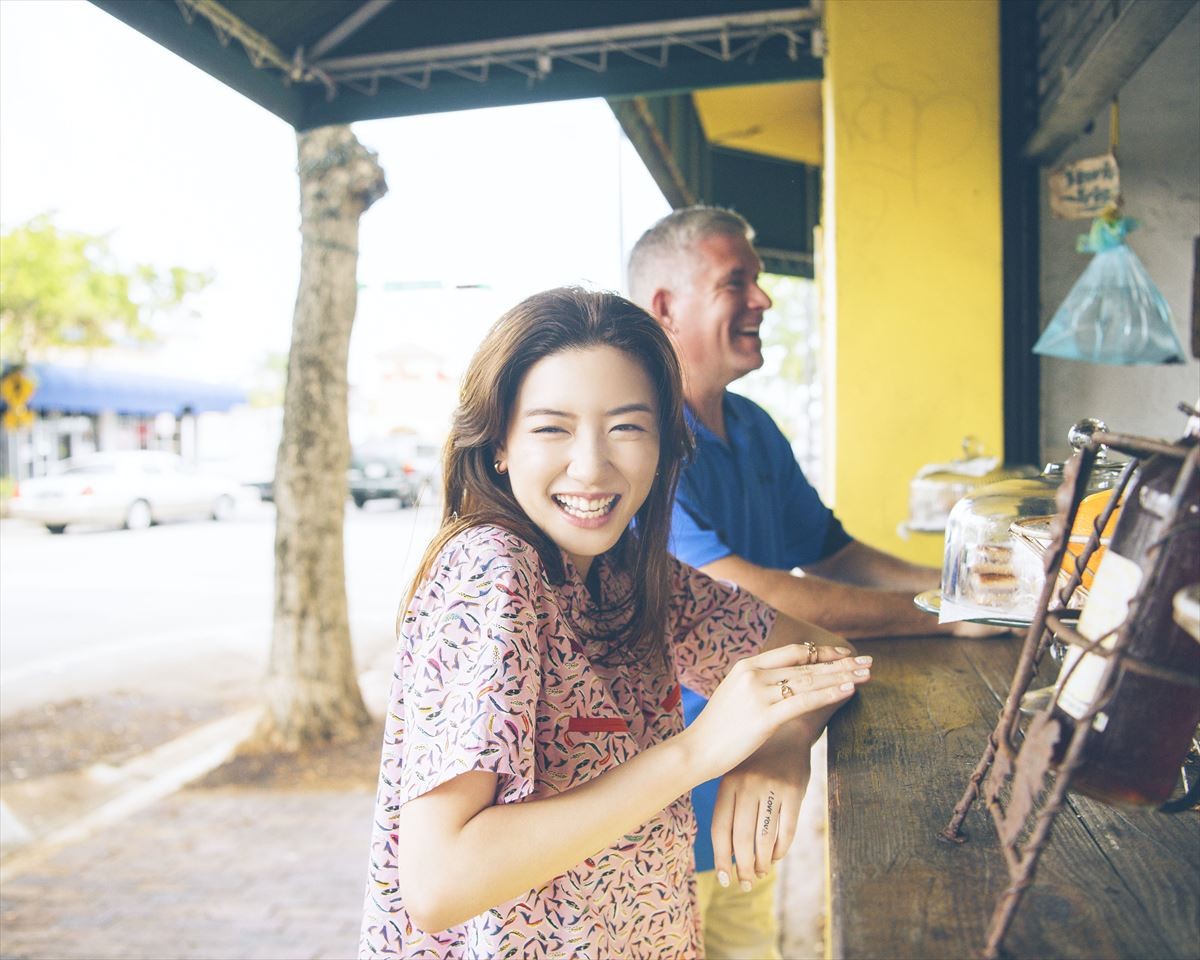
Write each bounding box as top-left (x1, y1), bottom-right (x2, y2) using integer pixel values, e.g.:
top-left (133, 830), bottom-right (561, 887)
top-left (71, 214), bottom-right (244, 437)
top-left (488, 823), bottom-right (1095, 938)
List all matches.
top-left (0, 786), bottom-right (373, 960)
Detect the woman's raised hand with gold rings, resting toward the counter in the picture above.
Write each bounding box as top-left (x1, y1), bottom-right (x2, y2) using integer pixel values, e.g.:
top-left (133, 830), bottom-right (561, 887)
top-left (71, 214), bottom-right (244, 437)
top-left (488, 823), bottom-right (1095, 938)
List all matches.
top-left (679, 643), bottom-right (871, 781)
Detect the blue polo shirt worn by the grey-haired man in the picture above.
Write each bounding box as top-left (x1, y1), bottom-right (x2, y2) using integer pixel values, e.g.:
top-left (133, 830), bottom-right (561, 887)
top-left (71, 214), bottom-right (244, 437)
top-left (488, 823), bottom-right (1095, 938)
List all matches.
top-left (670, 392), bottom-right (851, 870)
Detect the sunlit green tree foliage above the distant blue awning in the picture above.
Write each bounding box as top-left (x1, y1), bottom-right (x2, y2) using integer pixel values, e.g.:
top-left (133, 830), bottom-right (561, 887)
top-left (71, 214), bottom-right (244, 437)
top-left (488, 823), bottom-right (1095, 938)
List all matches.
top-left (0, 215), bottom-right (211, 362)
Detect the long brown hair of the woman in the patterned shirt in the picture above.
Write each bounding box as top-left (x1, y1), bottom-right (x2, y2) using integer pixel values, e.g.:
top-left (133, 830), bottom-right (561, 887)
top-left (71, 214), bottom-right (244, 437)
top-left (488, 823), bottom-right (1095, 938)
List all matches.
top-left (401, 287), bottom-right (692, 662)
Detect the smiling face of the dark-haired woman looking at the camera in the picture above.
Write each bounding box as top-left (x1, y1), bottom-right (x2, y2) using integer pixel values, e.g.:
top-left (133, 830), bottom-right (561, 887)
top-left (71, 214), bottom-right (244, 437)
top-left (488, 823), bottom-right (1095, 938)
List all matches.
top-left (497, 347), bottom-right (659, 576)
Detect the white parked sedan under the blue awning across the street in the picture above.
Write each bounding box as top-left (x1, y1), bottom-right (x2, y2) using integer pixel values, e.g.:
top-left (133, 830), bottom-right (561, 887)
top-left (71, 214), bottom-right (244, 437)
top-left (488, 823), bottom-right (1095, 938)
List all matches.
top-left (10, 450), bottom-right (238, 534)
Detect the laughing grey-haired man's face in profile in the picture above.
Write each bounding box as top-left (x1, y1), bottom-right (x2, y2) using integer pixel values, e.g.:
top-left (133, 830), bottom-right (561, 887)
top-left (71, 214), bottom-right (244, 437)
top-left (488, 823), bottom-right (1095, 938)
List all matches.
top-left (660, 234), bottom-right (770, 394)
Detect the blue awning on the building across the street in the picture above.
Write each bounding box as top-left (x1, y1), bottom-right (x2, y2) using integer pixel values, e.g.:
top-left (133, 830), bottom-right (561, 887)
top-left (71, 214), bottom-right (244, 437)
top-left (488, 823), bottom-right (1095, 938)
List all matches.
top-left (0, 364), bottom-right (246, 416)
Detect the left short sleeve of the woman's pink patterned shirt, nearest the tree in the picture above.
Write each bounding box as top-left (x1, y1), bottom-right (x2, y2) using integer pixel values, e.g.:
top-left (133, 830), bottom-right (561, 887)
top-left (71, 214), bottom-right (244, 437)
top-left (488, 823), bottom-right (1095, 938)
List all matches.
top-left (385, 528), bottom-right (541, 804)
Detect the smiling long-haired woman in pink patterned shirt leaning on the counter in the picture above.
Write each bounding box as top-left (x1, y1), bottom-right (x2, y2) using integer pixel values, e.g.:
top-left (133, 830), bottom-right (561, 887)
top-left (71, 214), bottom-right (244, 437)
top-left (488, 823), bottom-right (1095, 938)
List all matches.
top-left (360, 289), bottom-right (870, 958)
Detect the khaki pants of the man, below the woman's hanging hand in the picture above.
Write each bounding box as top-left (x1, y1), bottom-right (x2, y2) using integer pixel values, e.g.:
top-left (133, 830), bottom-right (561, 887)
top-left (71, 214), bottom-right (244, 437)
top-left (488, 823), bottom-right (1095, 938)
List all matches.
top-left (696, 865), bottom-right (780, 960)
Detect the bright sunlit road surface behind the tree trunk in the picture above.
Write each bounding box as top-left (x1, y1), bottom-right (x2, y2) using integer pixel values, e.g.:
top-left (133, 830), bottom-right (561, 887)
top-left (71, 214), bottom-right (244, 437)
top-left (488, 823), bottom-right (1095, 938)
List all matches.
top-left (0, 500), bottom-right (440, 716)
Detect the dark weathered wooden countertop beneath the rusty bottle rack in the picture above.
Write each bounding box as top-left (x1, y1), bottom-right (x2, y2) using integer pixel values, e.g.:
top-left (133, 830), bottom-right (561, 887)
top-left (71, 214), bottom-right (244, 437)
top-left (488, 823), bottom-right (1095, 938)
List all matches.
top-left (829, 638), bottom-right (1200, 960)
